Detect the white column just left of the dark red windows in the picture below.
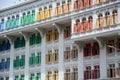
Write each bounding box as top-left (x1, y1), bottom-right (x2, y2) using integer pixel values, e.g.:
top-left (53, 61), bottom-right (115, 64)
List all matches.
top-left (76, 43), bottom-right (84, 80)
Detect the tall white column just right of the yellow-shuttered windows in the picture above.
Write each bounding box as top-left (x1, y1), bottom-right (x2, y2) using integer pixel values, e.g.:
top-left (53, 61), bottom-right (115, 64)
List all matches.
top-left (58, 26), bottom-right (64, 80)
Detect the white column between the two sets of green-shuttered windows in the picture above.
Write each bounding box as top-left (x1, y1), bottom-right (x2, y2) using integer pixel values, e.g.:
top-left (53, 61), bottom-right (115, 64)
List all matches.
top-left (24, 36), bottom-right (29, 80)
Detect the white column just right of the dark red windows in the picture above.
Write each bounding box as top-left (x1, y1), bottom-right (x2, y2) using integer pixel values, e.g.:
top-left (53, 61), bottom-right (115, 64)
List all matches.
top-left (100, 46), bottom-right (107, 79)
